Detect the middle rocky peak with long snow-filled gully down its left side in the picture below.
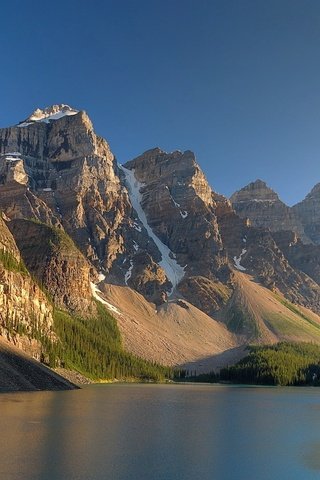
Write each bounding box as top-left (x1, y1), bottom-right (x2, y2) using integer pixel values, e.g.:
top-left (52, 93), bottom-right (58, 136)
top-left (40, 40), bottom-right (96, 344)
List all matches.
top-left (122, 148), bottom-right (230, 312)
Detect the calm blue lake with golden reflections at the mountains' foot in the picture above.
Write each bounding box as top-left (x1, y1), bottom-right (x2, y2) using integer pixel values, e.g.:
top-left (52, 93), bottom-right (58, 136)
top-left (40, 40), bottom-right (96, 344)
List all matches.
top-left (0, 384), bottom-right (320, 480)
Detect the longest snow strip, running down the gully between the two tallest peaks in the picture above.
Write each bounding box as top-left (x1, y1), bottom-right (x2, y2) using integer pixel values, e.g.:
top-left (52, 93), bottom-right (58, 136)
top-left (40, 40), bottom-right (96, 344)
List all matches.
top-left (119, 165), bottom-right (185, 295)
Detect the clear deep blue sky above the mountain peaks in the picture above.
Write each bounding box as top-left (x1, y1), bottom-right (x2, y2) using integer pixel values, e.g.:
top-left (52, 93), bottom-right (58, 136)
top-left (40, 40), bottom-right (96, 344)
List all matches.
top-left (0, 0), bottom-right (320, 204)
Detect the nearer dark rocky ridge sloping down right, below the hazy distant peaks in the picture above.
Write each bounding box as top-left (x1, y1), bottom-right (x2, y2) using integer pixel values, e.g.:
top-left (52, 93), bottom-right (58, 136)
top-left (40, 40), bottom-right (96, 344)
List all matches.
top-left (218, 202), bottom-right (320, 311)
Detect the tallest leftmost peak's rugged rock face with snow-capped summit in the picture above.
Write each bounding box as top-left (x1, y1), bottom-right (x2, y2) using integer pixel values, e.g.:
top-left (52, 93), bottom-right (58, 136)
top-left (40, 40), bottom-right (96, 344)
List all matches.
top-left (0, 106), bottom-right (129, 269)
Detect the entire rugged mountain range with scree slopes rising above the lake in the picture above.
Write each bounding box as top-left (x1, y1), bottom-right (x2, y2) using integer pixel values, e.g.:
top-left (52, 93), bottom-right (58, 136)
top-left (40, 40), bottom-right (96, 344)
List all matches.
top-left (0, 104), bottom-right (320, 386)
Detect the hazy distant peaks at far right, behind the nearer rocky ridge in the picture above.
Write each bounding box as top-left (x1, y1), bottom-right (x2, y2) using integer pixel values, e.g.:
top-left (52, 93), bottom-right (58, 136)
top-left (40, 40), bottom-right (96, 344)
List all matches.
top-left (230, 180), bottom-right (320, 311)
